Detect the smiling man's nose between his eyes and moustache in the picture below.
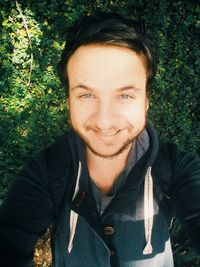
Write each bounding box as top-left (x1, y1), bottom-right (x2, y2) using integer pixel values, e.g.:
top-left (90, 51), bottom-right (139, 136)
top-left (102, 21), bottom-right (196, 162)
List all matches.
top-left (94, 99), bottom-right (117, 132)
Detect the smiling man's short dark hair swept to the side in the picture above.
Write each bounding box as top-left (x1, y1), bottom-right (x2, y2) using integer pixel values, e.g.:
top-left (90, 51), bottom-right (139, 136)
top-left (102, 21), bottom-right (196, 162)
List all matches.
top-left (57, 13), bottom-right (157, 96)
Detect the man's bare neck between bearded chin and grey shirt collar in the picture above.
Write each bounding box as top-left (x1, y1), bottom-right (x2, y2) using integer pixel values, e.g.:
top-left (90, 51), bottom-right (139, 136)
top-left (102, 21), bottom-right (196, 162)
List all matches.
top-left (86, 145), bottom-right (131, 193)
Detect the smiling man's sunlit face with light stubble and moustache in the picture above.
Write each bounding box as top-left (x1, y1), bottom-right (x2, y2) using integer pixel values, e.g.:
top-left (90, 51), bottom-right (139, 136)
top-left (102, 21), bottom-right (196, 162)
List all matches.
top-left (67, 45), bottom-right (148, 158)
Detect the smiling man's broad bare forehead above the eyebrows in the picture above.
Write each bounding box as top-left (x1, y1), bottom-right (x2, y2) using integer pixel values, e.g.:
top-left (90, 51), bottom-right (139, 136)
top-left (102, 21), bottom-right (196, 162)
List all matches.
top-left (67, 45), bottom-right (146, 91)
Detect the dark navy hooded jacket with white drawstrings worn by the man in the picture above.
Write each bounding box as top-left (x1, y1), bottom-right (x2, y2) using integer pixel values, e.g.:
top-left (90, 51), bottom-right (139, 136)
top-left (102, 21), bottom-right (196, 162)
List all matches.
top-left (0, 124), bottom-right (200, 267)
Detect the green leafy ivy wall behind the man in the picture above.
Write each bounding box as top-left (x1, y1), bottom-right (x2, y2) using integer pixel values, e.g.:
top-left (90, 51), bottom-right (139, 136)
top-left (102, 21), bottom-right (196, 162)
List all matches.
top-left (0, 0), bottom-right (200, 266)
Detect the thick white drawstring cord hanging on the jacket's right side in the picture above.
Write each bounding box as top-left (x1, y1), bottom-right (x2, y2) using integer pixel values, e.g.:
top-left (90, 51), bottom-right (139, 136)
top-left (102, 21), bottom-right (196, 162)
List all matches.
top-left (143, 167), bottom-right (154, 255)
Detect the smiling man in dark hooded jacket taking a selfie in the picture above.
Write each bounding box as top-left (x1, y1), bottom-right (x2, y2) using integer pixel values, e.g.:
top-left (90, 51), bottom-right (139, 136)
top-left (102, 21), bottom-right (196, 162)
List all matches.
top-left (0, 11), bottom-right (200, 267)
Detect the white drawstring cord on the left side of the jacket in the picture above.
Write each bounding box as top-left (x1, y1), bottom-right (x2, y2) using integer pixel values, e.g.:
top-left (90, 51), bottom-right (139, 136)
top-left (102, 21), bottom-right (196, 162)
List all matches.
top-left (67, 161), bottom-right (81, 253)
